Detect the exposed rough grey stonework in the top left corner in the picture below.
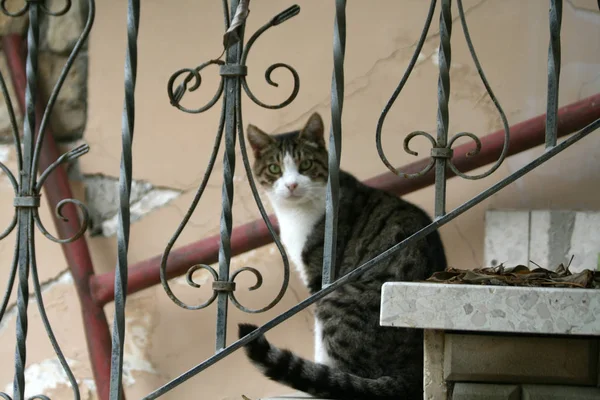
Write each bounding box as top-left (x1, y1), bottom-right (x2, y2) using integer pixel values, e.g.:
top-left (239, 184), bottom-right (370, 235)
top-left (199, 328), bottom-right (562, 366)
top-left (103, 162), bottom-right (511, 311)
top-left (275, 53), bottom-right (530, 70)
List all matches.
top-left (0, 0), bottom-right (88, 143)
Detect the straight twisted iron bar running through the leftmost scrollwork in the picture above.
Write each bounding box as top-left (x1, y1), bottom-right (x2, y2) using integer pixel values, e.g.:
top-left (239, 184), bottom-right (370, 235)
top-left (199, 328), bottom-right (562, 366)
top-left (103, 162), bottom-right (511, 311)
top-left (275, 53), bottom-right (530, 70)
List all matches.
top-left (13, 2), bottom-right (40, 400)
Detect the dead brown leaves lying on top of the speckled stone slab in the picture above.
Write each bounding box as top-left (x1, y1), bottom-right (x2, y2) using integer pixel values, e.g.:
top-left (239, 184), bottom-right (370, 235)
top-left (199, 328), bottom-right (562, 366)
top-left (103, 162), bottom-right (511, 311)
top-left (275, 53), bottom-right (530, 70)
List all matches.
top-left (427, 264), bottom-right (600, 289)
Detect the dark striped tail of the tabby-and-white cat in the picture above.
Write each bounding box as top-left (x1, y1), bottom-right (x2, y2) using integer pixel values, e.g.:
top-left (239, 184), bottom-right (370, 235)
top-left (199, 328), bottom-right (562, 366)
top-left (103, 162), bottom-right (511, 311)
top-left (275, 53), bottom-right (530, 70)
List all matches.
top-left (239, 324), bottom-right (412, 400)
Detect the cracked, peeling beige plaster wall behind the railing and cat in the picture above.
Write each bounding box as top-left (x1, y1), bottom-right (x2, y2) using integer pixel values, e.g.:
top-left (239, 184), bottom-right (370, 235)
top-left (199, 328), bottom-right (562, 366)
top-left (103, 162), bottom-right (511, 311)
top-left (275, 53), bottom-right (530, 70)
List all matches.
top-left (0, 0), bottom-right (600, 400)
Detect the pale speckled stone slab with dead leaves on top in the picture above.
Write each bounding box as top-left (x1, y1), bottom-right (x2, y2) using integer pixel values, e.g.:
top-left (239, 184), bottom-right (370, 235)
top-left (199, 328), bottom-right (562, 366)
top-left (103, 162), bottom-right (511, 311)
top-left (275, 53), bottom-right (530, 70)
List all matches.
top-left (380, 282), bottom-right (600, 336)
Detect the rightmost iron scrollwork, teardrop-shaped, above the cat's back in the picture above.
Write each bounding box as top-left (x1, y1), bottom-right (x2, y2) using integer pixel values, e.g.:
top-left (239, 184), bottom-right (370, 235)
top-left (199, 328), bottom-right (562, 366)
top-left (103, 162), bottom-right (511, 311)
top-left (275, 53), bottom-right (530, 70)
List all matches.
top-left (375, 0), bottom-right (510, 217)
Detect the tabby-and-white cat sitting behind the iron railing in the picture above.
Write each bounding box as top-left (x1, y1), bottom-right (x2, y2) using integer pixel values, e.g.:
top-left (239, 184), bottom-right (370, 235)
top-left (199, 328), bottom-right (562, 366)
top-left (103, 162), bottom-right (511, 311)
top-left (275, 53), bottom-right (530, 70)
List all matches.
top-left (239, 113), bottom-right (446, 400)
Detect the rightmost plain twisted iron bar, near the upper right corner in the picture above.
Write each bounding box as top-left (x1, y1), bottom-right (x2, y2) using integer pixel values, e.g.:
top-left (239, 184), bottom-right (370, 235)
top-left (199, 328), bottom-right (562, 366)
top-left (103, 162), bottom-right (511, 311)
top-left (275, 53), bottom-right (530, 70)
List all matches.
top-left (546, 0), bottom-right (563, 148)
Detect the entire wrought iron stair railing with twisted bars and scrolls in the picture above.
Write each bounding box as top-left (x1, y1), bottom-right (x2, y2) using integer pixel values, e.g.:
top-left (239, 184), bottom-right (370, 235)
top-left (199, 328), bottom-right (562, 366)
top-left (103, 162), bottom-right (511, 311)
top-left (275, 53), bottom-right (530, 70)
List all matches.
top-left (0, 0), bottom-right (600, 400)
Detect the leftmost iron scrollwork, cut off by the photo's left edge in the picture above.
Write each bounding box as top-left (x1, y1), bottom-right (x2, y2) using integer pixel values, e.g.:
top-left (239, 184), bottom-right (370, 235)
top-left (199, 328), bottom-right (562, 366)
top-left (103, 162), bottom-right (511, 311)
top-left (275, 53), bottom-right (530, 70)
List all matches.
top-left (0, 0), bottom-right (95, 400)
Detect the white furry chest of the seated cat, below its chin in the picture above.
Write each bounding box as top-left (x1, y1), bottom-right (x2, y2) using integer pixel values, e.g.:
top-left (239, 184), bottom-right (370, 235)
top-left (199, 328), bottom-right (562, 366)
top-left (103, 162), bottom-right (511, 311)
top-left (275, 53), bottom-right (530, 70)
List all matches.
top-left (277, 206), bottom-right (322, 285)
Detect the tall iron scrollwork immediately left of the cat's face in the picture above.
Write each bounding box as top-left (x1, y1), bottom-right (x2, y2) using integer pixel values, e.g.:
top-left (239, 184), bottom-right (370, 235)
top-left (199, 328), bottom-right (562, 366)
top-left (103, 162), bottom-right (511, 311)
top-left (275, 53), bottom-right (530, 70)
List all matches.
top-left (160, 0), bottom-right (300, 349)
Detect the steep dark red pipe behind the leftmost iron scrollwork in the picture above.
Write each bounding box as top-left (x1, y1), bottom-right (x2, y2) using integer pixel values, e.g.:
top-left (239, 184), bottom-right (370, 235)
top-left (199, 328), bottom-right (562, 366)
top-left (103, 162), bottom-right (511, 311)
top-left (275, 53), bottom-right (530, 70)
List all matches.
top-left (2, 34), bottom-right (119, 400)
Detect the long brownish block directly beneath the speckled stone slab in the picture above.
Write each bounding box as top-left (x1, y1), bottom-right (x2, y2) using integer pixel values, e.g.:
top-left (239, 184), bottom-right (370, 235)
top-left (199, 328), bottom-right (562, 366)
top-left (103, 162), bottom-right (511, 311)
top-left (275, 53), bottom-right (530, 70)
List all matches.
top-left (444, 333), bottom-right (598, 385)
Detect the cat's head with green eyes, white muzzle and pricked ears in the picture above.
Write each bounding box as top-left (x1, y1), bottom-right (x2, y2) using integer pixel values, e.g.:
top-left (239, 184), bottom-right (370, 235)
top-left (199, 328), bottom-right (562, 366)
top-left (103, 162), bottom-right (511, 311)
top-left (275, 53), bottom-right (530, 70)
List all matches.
top-left (248, 113), bottom-right (328, 205)
